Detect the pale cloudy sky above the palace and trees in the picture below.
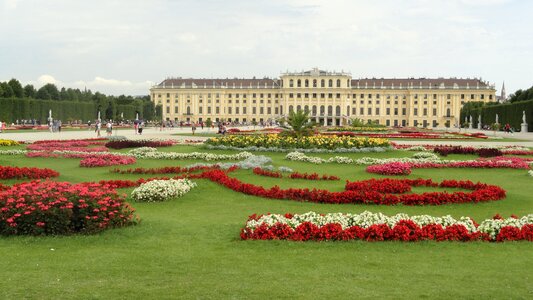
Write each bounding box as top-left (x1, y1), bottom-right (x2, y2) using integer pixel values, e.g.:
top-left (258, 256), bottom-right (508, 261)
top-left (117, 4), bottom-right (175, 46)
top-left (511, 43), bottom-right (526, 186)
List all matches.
top-left (0, 0), bottom-right (533, 95)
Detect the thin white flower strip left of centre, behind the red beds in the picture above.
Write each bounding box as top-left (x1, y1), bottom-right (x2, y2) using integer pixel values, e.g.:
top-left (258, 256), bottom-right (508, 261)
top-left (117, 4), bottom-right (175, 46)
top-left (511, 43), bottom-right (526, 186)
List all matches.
top-left (128, 147), bottom-right (253, 161)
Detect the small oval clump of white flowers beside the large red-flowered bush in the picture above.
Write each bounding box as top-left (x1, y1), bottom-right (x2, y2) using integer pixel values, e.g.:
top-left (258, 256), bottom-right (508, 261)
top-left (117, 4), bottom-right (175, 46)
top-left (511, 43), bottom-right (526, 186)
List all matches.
top-left (131, 179), bottom-right (196, 202)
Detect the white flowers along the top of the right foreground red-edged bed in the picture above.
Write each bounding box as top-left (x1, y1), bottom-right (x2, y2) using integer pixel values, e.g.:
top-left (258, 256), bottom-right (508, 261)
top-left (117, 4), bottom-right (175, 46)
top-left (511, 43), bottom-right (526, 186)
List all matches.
top-left (246, 211), bottom-right (533, 240)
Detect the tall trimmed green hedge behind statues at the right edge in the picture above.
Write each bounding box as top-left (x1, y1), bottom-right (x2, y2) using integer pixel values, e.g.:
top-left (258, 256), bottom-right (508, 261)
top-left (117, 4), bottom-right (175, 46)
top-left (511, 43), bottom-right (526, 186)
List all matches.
top-left (461, 100), bottom-right (533, 131)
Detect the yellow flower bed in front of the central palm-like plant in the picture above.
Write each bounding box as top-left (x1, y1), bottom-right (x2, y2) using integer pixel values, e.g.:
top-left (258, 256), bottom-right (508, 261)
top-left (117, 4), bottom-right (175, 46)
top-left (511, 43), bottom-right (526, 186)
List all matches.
top-left (205, 134), bottom-right (389, 150)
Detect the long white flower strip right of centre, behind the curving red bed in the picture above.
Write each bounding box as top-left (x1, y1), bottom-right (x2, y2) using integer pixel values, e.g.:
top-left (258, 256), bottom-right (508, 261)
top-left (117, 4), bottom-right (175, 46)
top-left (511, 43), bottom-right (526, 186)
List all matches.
top-left (285, 152), bottom-right (451, 165)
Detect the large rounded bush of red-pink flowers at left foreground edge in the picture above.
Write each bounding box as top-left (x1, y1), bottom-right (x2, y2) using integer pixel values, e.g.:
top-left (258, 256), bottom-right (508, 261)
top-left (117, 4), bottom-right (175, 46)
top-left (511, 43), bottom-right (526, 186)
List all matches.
top-left (0, 181), bottom-right (137, 235)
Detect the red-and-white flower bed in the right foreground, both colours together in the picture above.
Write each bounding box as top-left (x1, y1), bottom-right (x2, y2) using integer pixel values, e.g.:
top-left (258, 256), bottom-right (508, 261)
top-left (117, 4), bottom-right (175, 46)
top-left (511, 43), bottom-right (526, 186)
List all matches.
top-left (241, 211), bottom-right (533, 242)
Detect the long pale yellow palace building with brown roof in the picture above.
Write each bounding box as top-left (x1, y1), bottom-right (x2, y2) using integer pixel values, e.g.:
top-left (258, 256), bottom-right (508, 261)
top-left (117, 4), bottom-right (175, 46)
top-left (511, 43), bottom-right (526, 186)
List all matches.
top-left (150, 68), bottom-right (496, 127)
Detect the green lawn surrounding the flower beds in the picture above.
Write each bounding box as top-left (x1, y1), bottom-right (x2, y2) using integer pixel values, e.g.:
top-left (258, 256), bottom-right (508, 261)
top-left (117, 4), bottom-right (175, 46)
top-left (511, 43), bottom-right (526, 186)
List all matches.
top-left (0, 146), bottom-right (533, 299)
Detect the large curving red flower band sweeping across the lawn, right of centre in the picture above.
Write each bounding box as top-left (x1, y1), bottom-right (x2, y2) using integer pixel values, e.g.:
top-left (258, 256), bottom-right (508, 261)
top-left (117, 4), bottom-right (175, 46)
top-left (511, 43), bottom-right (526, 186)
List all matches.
top-left (201, 170), bottom-right (505, 205)
